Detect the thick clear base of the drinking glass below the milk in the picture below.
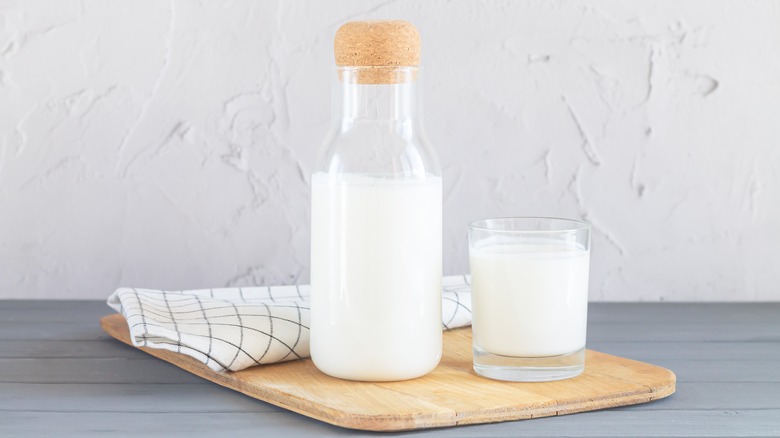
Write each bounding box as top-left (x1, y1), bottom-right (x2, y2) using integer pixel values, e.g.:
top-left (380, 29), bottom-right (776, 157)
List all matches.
top-left (474, 347), bottom-right (585, 382)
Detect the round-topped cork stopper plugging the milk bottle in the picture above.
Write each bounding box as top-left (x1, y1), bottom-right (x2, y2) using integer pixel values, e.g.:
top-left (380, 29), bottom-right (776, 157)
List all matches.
top-left (333, 20), bottom-right (420, 84)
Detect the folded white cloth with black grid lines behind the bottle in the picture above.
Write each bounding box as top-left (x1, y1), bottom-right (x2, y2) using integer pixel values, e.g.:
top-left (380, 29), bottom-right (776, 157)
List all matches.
top-left (108, 275), bottom-right (471, 372)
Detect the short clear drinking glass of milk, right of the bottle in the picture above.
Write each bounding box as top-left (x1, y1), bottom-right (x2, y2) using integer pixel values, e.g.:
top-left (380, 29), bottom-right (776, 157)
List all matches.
top-left (469, 217), bottom-right (590, 382)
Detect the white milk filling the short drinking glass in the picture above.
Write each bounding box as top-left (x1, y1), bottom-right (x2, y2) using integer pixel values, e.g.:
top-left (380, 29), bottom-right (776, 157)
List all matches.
top-left (470, 242), bottom-right (589, 357)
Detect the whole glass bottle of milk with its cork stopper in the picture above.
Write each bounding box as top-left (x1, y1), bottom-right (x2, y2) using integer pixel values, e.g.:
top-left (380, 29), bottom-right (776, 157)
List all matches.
top-left (311, 21), bottom-right (442, 381)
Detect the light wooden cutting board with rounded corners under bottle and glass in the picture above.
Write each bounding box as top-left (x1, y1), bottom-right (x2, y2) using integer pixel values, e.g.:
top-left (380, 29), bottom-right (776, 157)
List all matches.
top-left (100, 314), bottom-right (676, 431)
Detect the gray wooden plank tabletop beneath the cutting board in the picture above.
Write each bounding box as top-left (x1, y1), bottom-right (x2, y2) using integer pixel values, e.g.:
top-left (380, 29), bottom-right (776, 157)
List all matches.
top-left (0, 301), bottom-right (780, 438)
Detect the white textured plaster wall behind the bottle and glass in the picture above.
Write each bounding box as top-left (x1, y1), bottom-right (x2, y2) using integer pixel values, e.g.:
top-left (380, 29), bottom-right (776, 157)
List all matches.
top-left (0, 0), bottom-right (780, 301)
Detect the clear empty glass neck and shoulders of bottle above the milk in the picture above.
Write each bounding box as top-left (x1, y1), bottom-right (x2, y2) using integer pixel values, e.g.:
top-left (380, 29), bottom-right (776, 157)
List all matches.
top-left (315, 67), bottom-right (441, 179)
